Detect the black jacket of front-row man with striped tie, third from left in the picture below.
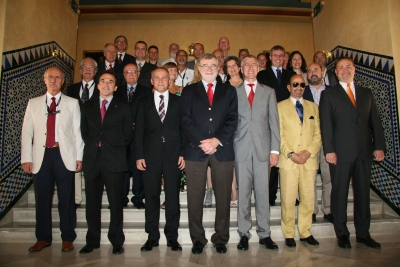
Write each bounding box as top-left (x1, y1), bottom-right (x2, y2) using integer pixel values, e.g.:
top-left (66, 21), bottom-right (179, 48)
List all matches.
top-left (134, 93), bottom-right (183, 163)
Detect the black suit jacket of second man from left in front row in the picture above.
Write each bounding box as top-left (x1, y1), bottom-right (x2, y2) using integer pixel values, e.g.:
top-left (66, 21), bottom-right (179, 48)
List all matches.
top-left (81, 97), bottom-right (133, 172)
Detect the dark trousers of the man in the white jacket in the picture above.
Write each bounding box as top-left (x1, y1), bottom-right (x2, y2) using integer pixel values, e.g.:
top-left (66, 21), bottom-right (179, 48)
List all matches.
top-left (33, 147), bottom-right (76, 243)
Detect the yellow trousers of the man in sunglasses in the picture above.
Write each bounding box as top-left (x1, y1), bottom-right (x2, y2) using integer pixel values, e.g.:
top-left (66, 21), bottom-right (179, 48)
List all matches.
top-left (279, 164), bottom-right (317, 238)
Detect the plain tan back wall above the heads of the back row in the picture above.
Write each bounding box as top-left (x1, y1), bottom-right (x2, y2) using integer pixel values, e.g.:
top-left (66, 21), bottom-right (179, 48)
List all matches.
top-left (74, 20), bottom-right (314, 81)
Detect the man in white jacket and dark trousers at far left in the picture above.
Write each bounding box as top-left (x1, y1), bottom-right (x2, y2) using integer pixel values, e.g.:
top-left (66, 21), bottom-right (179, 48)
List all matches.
top-left (21, 67), bottom-right (84, 252)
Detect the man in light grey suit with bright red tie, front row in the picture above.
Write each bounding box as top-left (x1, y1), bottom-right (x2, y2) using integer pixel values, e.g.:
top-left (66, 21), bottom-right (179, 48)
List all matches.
top-left (233, 56), bottom-right (280, 250)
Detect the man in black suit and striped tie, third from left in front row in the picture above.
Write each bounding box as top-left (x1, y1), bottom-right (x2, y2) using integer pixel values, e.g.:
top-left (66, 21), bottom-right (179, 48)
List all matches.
top-left (135, 68), bottom-right (185, 251)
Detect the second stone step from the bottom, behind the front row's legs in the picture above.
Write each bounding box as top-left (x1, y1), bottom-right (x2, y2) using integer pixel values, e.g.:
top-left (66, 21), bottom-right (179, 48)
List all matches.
top-left (13, 199), bottom-right (383, 226)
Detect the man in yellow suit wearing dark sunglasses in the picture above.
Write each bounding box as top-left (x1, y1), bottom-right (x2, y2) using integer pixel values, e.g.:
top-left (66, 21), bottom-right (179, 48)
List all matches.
top-left (277, 75), bottom-right (321, 247)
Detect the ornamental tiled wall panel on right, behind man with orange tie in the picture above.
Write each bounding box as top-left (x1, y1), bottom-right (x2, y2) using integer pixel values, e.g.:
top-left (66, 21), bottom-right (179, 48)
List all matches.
top-left (328, 46), bottom-right (400, 215)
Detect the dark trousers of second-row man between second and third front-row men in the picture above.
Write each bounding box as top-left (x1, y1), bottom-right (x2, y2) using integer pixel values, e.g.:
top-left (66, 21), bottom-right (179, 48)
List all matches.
top-left (122, 142), bottom-right (145, 204)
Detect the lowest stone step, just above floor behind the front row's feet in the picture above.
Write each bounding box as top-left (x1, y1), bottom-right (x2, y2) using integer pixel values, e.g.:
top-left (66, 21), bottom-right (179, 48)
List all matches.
top-left (0, 213), bottom-right (400, 246)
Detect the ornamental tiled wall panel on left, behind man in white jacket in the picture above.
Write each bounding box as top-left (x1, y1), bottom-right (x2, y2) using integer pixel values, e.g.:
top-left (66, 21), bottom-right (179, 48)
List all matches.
top-left (0, 42), bottom-right (74, 220)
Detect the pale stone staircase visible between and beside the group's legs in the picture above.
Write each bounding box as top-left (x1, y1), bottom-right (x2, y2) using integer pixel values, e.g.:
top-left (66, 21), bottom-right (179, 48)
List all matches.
top-left (0, 175), bottom-right (400, 245)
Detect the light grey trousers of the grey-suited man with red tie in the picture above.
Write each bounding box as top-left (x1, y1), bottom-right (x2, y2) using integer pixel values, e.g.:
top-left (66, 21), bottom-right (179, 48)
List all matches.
top-left (235, 150), bottom-right (271, 239)
